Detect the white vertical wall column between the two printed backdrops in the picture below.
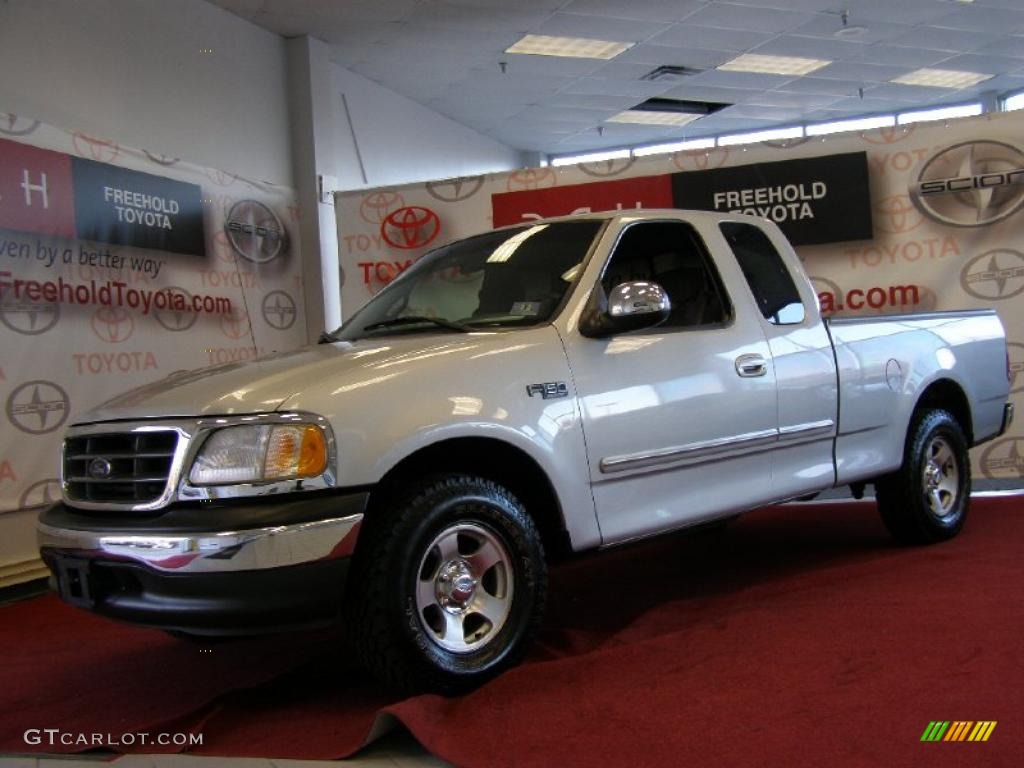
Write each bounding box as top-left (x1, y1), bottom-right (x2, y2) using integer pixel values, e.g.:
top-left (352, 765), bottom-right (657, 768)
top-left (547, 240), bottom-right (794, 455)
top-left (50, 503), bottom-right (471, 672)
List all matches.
top-left (287, 35), bottom-right (341, 341)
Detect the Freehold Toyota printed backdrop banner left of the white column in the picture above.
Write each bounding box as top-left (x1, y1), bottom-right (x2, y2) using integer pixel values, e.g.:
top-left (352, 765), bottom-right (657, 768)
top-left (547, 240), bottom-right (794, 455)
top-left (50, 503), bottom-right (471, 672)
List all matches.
top-left (0, 113), bottom-right (305, 518)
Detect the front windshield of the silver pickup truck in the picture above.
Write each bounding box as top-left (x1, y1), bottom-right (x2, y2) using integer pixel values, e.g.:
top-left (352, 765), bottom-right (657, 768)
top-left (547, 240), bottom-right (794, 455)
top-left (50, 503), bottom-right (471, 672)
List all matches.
top-left (332, 219), bottom-right (604, 340)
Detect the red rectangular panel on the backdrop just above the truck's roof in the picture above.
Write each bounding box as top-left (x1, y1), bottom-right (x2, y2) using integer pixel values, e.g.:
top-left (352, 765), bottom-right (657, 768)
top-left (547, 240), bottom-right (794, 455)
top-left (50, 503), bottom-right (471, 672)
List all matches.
top-left (490, 174), bottom-right (673, 226)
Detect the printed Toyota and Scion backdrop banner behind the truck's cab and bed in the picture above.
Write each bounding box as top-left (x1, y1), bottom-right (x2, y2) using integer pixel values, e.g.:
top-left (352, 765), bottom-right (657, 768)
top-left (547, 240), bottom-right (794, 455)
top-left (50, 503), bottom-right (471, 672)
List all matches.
top-left (335, 112), bottom-right (1024, 478)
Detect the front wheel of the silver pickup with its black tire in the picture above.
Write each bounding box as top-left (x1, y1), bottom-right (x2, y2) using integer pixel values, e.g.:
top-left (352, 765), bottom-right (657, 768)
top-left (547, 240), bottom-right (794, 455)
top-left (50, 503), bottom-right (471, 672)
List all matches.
top-left (344, 475), bottom-right (548, 693)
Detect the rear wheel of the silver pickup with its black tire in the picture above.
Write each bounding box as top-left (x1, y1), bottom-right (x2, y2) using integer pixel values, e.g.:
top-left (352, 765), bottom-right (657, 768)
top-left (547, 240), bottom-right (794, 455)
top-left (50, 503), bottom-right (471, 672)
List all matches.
top-left (874, 410), bottom-right (971, 544)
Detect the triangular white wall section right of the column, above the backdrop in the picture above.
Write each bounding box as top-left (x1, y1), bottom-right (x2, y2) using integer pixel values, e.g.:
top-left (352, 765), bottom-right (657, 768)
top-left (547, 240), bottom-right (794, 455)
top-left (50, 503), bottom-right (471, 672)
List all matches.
top-left (334, 66), bottom-right (524, 189)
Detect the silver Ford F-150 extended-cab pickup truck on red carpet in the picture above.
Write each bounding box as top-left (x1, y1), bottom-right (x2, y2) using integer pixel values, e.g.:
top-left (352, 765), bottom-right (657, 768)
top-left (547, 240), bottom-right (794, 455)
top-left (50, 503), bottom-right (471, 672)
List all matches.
top-left (38, 211), bottom-right (1013, 691)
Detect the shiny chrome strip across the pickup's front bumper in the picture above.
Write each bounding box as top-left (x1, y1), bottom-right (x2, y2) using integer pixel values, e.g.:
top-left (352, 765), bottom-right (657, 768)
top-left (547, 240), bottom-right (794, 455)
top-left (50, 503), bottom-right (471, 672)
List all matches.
top-left (36, 514), bottom-right (362, 573)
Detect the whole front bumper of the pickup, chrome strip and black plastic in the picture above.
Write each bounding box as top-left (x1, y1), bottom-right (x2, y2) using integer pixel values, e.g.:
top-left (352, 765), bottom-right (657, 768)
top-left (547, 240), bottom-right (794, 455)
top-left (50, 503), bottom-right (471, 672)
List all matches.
top-left (37, 493), bottom-right (368, 635)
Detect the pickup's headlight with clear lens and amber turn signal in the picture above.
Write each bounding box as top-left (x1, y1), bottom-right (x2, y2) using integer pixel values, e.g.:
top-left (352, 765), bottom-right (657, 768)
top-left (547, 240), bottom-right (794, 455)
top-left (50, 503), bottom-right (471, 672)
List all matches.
top-left (188, 424), bottom-right (327, 485)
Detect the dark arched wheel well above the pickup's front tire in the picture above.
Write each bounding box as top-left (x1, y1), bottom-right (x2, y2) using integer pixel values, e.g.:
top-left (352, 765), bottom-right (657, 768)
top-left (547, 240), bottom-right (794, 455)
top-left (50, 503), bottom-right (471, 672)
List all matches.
top-left (368, 437), bottom-right (571, 560)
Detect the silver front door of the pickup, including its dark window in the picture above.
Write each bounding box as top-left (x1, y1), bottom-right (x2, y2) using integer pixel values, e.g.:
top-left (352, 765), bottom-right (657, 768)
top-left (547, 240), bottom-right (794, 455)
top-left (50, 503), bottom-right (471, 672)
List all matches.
top-left (566, 220), bottom-right (778, 544)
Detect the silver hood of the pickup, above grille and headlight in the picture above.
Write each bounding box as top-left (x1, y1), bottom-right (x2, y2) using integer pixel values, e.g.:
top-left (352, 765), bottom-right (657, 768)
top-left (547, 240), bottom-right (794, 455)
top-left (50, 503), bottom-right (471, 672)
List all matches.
top-left (75, 334), bottom-right (491, 424)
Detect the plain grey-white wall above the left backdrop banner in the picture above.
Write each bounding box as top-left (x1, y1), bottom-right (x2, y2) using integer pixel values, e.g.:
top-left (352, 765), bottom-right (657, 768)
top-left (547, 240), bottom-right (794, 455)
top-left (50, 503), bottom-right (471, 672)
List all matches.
top-left (0, 0), bottom-right (293, 184)
